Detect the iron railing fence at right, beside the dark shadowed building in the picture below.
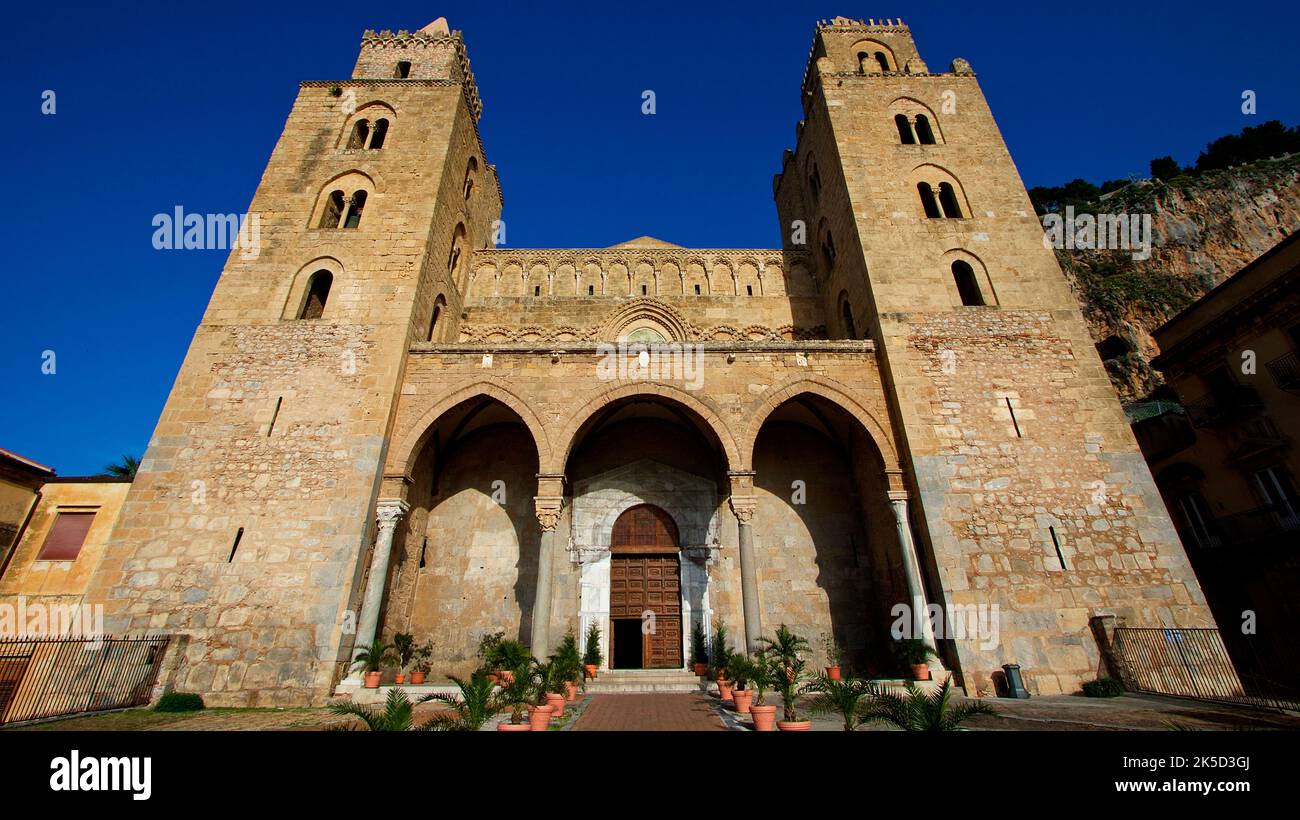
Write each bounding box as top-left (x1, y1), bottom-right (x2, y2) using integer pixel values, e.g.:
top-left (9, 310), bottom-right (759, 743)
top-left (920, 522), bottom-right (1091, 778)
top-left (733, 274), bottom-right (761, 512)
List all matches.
top-left (1115, 626), bottom-right (1300, 710)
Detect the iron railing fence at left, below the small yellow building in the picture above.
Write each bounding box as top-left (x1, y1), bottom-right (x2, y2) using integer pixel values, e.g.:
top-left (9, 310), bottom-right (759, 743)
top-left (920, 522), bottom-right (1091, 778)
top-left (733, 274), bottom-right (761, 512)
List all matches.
top-left (0, 635), bottom-right (168, 725)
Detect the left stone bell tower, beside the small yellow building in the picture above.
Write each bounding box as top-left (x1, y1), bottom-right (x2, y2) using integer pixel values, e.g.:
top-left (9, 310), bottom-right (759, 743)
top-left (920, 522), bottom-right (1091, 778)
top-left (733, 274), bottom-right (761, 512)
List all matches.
top-left (92, 19), bottom-right (501, 706)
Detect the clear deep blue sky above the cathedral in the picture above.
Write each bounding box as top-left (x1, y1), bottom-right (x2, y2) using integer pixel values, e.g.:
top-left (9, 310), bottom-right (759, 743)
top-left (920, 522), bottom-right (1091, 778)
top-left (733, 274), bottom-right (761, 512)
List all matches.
top-left (0, 0), bottom-right (1300, 476)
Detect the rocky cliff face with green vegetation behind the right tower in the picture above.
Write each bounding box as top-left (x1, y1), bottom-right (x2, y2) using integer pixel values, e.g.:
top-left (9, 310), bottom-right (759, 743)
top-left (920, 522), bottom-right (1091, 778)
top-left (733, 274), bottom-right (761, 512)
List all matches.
top-left (1057, 155), bottom-right (1300, 403)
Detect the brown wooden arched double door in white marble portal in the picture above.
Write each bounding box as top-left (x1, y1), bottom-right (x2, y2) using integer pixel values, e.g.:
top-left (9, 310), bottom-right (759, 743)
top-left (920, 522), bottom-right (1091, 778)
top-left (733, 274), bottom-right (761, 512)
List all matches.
top-left (610, 504), bottom-right (683, 669)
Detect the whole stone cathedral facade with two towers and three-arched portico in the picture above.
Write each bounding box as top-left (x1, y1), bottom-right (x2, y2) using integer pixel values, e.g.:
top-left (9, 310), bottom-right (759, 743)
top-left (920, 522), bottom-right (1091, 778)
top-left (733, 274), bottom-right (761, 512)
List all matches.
top-left (88, 18), bottom-right (1214, 706)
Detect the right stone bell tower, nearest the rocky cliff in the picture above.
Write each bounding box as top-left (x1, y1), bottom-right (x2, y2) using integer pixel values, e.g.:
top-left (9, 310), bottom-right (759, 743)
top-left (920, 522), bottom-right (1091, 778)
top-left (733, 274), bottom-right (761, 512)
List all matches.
top-left (775, 17), bottom-right (1213, 693)
